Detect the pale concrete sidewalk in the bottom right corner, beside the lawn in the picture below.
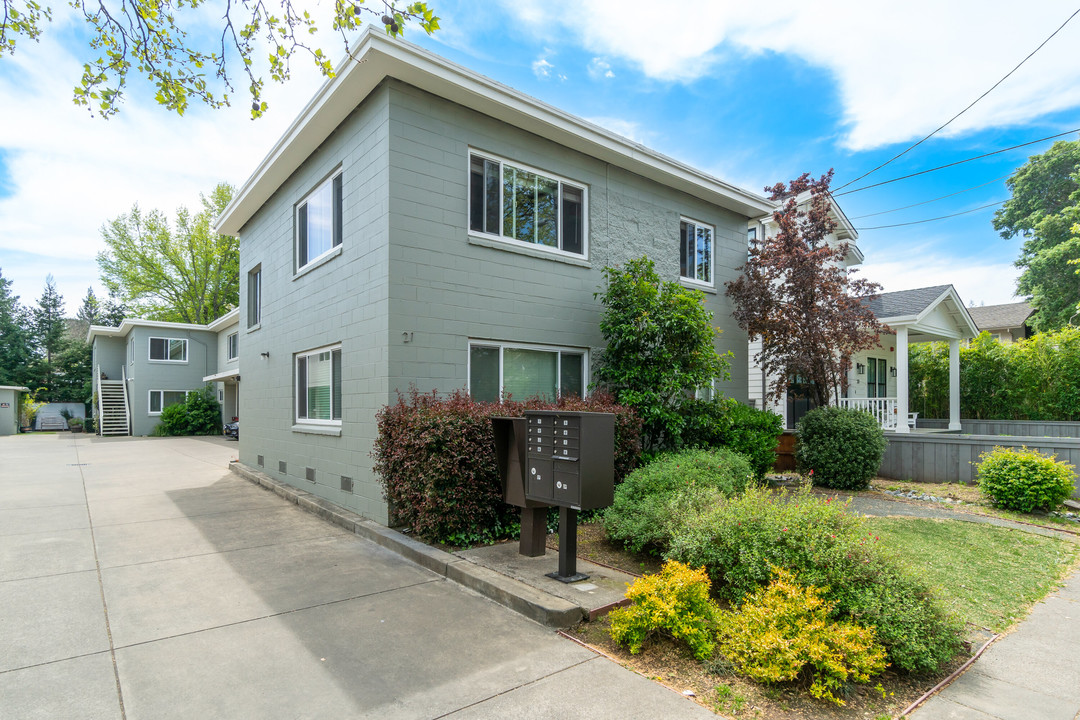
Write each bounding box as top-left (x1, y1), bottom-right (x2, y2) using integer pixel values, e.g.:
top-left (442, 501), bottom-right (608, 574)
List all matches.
top-left (909, 572), bottom-right (1080, 720)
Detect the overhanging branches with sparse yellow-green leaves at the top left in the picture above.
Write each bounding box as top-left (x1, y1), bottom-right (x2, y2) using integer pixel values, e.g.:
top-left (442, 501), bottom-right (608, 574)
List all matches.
top-left (0, 0), bottom-right (438, 118)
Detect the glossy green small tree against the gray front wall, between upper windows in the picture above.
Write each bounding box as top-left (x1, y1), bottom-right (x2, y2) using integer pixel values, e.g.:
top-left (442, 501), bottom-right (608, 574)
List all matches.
top-left (596, 258), bottom-right (730, 451)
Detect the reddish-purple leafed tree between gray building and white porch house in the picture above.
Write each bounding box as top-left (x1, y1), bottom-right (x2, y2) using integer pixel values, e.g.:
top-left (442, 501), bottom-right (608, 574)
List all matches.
top-left (727, 171), bottom-right (886, 406)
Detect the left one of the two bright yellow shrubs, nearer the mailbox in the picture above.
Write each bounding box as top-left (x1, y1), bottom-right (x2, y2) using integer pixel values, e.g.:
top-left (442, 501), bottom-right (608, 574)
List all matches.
top-left (609, 561), bottom-right (719, 660)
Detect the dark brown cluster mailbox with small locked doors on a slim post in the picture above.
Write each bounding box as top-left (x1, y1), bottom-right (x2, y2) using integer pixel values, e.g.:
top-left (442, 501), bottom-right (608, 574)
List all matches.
top-left (525, 410), bottom-right (615, 583)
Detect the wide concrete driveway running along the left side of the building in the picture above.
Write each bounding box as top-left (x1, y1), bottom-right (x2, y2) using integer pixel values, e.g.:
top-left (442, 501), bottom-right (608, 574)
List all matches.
top-left (0, 433), bottom-right (714, 720)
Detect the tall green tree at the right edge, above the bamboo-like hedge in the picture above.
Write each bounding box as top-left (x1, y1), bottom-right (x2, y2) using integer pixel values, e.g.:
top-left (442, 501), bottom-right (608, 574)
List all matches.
top-left (994, 140), bottom-right (1080, 331)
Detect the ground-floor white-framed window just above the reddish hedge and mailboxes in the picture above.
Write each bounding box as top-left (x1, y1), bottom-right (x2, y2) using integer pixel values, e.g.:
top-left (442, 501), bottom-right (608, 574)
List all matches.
top-left (469, 340), bottom-right (589, 403)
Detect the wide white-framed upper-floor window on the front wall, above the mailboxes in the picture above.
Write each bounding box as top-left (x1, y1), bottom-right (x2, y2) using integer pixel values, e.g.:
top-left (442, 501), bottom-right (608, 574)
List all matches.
top-left (469, 153), bottom-right (589, 255)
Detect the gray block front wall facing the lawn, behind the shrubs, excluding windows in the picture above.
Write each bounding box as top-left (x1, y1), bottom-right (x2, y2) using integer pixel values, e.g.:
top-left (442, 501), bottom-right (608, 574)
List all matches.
top-left (389, 82), bottom-right (747, 403)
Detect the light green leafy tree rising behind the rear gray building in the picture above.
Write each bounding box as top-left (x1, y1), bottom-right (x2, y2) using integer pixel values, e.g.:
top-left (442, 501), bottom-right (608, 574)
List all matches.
top-left (97, 182), bottom-right (240, 325)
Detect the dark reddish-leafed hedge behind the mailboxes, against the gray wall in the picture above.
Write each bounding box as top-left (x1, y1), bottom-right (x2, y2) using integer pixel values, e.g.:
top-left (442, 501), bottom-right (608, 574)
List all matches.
top-left (372, 390), bottom-right (642, 545)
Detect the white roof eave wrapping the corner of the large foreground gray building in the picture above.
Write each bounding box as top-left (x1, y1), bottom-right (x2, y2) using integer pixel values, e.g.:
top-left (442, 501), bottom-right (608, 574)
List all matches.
top-left (214, 27), bottom-right (773, 235)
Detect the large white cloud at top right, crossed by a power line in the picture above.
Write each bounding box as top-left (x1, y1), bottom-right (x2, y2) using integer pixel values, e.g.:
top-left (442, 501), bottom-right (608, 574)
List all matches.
top-left (503, 0), bottom-right (1080, 150)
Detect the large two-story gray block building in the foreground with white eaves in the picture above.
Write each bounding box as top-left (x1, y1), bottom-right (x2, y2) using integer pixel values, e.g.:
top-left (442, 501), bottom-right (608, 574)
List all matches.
top-left (216, 29), bottom-right (772, 522)
